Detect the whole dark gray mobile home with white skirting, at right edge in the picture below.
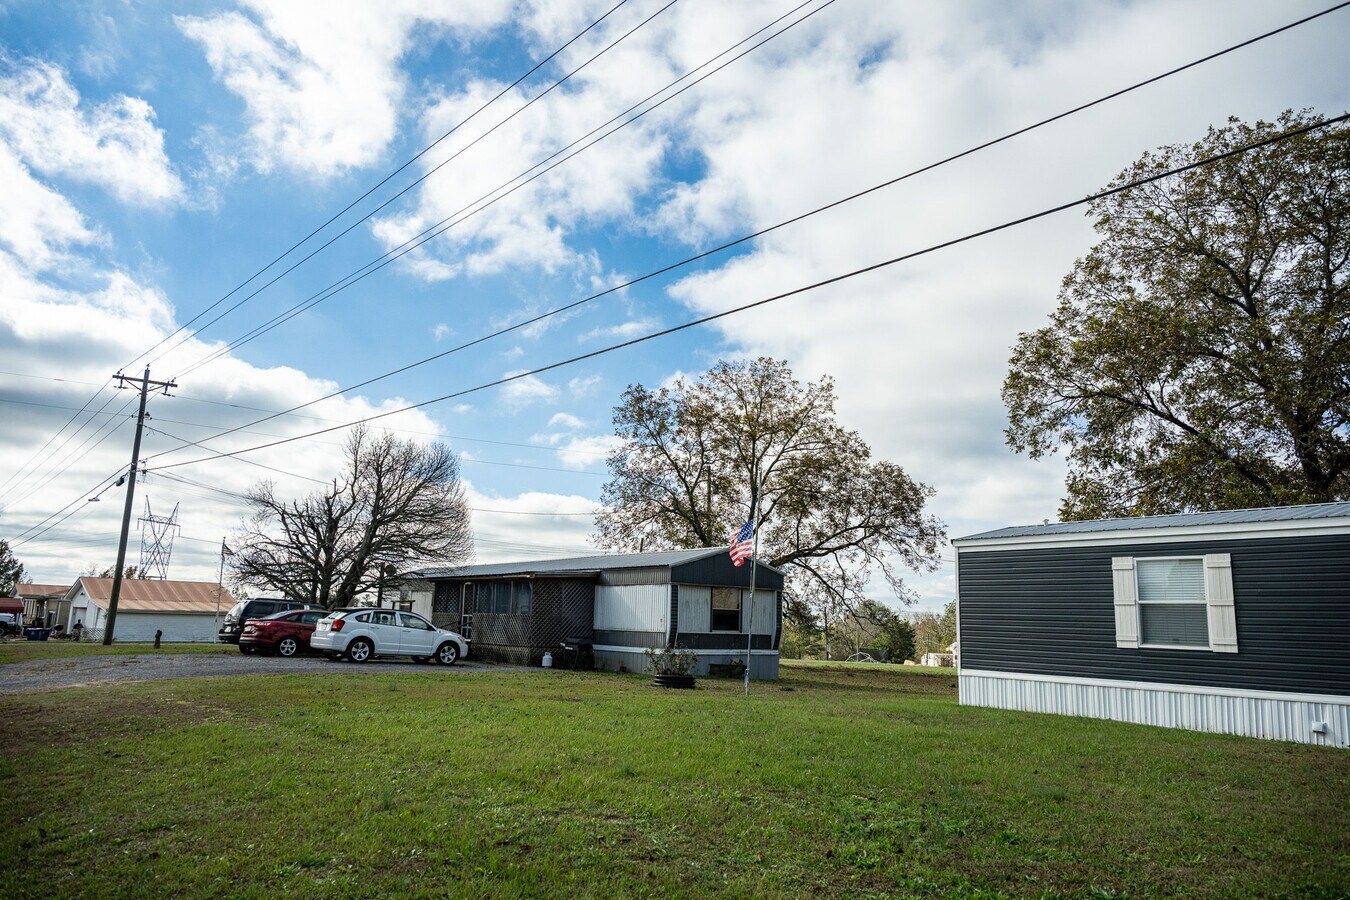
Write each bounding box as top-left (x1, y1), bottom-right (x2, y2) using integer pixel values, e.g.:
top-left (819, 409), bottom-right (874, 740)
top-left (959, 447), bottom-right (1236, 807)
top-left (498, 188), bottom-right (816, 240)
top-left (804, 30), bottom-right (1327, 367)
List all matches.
top-left (953, 502), bottom-right (1350, 746)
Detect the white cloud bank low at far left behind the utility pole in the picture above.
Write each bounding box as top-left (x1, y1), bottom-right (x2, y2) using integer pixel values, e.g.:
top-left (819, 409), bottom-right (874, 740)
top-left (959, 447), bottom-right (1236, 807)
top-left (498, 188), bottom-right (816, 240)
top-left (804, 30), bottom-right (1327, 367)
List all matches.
top-left (0, 194), bottom-right (439, 582)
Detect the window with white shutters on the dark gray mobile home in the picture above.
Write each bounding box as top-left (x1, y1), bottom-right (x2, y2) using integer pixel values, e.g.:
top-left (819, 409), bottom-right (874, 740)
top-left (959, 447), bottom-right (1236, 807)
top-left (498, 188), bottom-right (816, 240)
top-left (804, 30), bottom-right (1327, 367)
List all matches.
top-left (1111, 553), bottom-right (1238, 653)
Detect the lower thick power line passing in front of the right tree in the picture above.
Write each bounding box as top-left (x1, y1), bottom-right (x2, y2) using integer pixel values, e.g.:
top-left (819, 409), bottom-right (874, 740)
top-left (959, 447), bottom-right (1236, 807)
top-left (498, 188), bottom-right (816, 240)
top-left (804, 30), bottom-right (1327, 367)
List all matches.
top-left (147, 113), bottom-right (1350, 477)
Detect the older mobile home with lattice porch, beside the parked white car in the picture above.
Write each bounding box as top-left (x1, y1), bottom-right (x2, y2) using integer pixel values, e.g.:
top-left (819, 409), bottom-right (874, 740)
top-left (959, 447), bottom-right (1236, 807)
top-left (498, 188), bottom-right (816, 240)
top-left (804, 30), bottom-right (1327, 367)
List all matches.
top-left (400, 548), bottom-right (783, 679)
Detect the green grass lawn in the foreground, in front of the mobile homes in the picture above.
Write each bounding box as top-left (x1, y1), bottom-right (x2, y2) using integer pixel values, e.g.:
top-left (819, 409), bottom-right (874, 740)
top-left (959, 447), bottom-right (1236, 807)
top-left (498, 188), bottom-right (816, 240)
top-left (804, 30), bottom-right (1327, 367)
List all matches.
top-left (0, 665), bottom-right (1350, 897)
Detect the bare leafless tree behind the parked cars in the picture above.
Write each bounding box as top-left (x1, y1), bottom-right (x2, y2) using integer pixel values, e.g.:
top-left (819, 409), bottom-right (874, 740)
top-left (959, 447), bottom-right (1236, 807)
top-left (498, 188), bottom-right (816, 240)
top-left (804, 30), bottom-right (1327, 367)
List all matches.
top-left (230, 428), bottom-right (474, 609)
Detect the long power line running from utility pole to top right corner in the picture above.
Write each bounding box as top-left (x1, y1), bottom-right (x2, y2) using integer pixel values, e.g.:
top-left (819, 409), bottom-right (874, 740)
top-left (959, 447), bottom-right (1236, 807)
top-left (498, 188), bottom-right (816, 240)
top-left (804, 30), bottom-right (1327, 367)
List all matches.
top-left (134, 0), bottom-right (1350, 459)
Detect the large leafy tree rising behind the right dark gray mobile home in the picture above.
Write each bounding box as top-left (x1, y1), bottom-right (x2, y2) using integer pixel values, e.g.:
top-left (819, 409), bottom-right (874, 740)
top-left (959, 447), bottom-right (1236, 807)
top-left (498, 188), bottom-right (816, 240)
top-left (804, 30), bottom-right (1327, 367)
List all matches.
top-left (1003, 112), bottom-right (1350, 519)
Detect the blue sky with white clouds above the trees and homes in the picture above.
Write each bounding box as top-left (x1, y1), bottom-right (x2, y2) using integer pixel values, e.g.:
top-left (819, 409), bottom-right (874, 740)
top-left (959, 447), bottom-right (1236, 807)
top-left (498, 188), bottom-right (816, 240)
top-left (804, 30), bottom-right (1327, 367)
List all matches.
top-left (0, 0), bottom-right (1350, 607)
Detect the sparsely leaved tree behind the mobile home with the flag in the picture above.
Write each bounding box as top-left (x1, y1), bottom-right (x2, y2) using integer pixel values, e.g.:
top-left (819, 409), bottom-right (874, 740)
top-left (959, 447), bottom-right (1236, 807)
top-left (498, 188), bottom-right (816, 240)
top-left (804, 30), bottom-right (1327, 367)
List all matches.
top-left (597, 359), bottom-right (945, 609)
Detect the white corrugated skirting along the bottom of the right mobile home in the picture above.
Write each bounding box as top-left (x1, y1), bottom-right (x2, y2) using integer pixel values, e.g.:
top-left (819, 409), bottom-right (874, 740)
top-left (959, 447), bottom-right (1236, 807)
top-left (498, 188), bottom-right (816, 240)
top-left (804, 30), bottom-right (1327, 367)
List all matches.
top-left (960, 669), bottom-right (1350, 748)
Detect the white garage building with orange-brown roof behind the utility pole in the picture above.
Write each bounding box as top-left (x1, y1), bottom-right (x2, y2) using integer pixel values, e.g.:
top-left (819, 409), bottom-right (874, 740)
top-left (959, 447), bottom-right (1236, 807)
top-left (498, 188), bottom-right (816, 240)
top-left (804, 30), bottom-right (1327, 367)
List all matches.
top-left (65, 576), bottom-right (235, 644)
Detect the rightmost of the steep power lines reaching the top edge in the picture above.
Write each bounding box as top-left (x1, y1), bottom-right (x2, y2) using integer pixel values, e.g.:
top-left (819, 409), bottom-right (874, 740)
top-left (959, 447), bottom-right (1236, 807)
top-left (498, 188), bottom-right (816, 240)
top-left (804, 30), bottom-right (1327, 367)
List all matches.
top-left (171, 0), bottom-right (834, 375)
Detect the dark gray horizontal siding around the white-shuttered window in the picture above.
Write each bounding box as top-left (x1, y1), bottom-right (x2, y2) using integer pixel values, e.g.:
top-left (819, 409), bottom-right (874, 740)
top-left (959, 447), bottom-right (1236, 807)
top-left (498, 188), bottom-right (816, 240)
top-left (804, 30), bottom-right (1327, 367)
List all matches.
top-left (959, 536), bottom-right (1350, 695)
